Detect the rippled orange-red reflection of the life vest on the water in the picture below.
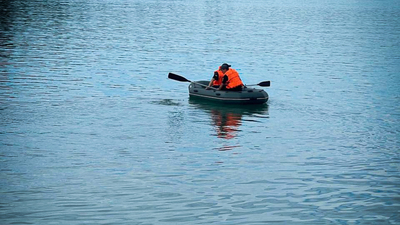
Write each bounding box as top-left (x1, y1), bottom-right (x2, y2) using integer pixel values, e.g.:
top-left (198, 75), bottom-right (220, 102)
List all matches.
top-left (211, 110), bottom-right (242, 139)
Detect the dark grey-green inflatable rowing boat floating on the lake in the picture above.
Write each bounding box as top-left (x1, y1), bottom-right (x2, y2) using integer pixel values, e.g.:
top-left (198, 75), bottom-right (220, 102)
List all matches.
top-left (189, 81), bottom-right (268, 104)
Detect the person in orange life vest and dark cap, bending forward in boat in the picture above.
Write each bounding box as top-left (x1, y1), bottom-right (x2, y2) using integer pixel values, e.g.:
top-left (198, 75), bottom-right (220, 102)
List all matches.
top-left (207, 63), bottom-right (244, 91)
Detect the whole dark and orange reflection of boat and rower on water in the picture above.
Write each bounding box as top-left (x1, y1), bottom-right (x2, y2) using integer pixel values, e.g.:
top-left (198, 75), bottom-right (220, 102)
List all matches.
top-left (189, 99), bottom-right (268, 139)
